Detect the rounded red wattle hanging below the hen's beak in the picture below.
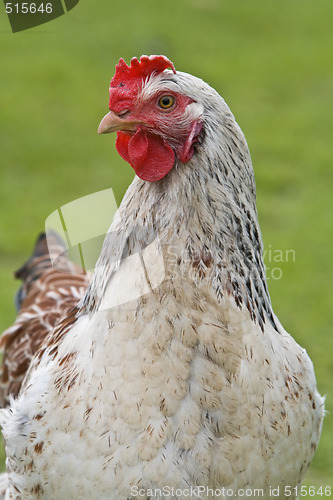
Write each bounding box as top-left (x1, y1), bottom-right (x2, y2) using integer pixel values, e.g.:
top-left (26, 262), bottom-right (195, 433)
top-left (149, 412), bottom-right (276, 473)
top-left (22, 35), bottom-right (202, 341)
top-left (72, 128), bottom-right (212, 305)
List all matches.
top-left (116, 129), bottom-right (175, 182)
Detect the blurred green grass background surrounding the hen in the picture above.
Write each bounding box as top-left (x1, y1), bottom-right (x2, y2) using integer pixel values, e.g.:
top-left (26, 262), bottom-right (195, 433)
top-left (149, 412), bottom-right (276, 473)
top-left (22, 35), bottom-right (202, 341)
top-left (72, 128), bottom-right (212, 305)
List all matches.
top-left (0, 0), bottom-right (333, 492)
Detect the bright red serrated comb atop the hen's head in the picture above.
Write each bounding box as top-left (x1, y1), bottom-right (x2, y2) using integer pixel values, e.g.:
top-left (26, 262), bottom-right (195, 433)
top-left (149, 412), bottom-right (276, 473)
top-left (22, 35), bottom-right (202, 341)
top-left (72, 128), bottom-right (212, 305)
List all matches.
top-left (110, 56), bottom-right (176, 87)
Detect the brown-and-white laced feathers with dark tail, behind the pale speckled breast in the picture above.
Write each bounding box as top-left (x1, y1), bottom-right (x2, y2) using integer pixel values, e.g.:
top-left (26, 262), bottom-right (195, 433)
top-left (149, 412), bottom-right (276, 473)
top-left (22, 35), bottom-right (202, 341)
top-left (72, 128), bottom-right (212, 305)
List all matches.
top-left (0, 232), bottom-right (89, 407)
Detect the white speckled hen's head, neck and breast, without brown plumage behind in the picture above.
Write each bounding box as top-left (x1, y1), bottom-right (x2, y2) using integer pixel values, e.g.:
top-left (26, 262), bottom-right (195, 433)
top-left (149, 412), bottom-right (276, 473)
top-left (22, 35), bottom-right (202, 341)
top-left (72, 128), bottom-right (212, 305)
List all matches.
top-left (0, 56), bottom-right (324, 500)
